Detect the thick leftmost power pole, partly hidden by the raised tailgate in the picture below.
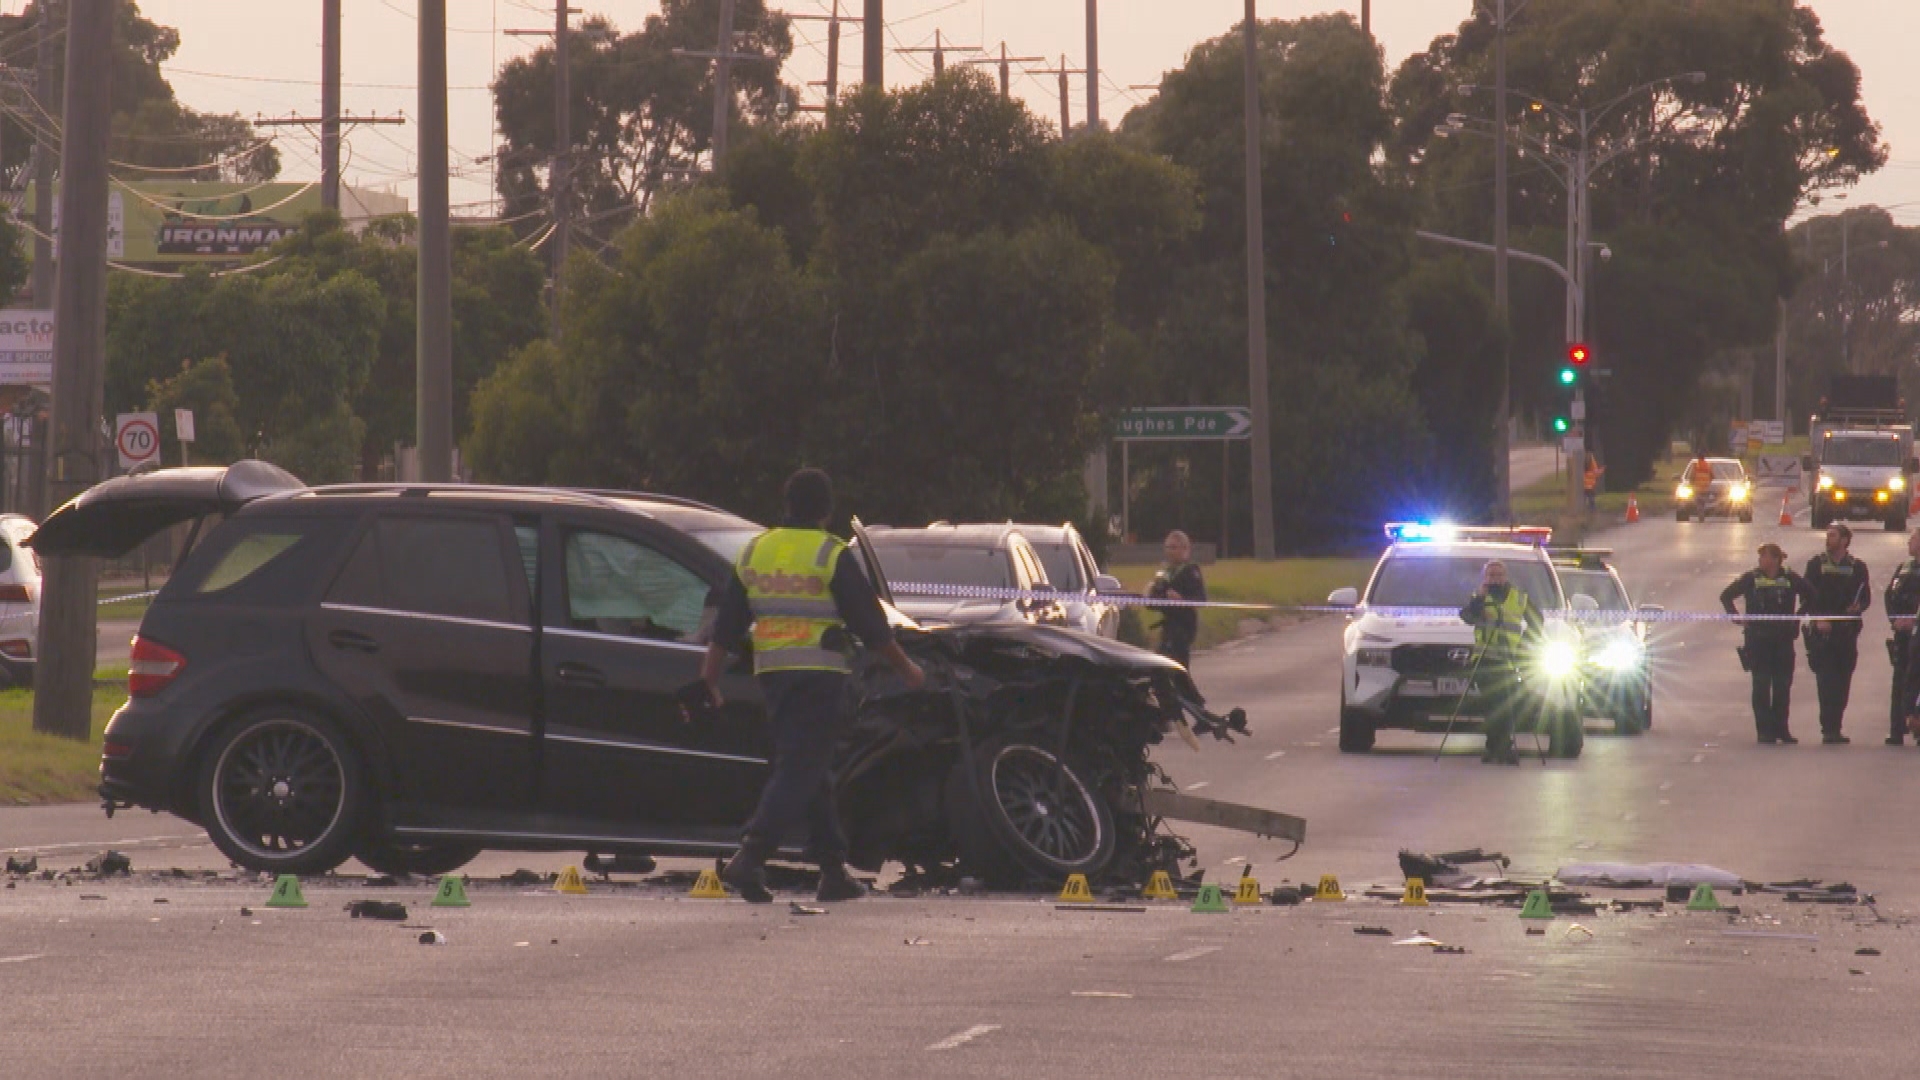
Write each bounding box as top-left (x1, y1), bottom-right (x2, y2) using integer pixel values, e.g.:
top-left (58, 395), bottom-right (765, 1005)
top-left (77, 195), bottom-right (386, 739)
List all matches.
top-left (33, 0), bottom-right (119, 740)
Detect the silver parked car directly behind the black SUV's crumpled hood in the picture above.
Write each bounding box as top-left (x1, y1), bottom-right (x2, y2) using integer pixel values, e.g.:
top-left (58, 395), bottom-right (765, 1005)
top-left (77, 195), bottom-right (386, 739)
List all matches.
top-left (862, 521), bottom-right (1071, 626)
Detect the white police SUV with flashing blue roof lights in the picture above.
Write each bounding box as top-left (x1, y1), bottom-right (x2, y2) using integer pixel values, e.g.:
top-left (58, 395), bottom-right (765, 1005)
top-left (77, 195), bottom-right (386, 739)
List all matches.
top-left (1327, 523), bottom-right (1594, 757)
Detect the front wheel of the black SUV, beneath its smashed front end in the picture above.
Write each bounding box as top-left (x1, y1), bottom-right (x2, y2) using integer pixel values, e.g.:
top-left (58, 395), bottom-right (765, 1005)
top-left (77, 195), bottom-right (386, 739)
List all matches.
top-left (947, 740), bottom-right (1116, 888)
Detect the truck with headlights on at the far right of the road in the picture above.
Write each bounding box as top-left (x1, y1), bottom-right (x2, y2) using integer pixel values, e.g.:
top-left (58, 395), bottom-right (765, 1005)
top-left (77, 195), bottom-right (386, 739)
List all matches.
top-left (1801, 375), bottom-right (1920, 532)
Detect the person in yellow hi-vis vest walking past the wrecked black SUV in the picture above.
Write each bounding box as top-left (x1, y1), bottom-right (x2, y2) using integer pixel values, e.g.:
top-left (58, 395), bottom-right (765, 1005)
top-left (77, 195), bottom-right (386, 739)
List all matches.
top-left (701, 469), bottom-right (925, 903)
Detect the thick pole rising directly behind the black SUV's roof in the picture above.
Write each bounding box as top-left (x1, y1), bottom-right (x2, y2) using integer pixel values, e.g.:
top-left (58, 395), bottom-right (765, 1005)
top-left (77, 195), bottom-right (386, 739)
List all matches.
top-left (413, 0), bottom-right (453, 484)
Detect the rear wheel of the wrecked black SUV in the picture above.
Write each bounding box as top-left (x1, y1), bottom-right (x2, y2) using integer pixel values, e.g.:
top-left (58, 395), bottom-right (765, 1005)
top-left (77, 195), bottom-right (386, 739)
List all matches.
top-left (198, 705), bottom-right (369, 874)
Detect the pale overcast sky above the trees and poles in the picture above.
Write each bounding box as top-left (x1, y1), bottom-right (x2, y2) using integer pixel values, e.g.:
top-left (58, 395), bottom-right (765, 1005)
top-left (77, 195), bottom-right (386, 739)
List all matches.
top-left (135, 0), bottom-right (1920, 225)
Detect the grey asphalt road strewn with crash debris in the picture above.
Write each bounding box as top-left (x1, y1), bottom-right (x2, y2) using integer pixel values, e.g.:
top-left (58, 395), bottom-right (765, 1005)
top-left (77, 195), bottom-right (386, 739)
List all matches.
top-left (0, 490), bottom-right (1920, 1078)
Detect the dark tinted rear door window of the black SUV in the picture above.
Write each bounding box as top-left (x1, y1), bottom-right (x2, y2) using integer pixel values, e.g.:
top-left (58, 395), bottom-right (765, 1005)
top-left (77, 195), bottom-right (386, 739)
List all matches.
top-left (326, 517), bottom-right (522, 623)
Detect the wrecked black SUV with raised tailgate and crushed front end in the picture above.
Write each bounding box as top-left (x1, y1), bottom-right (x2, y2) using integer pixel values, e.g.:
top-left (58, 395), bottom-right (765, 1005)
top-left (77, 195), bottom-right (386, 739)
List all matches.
top-left (45, 461), bottom-right (1244, 880)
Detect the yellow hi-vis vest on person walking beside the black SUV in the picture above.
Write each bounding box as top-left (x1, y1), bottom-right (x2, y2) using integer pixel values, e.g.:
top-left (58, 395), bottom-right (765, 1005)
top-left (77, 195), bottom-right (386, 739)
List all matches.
top-left (735, 528), bottom-right (852, 675)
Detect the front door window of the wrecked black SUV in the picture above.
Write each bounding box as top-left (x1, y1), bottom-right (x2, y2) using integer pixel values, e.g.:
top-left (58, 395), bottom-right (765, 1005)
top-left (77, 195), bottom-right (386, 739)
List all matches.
top-left (566, 530), bottom-right (708, 642)
